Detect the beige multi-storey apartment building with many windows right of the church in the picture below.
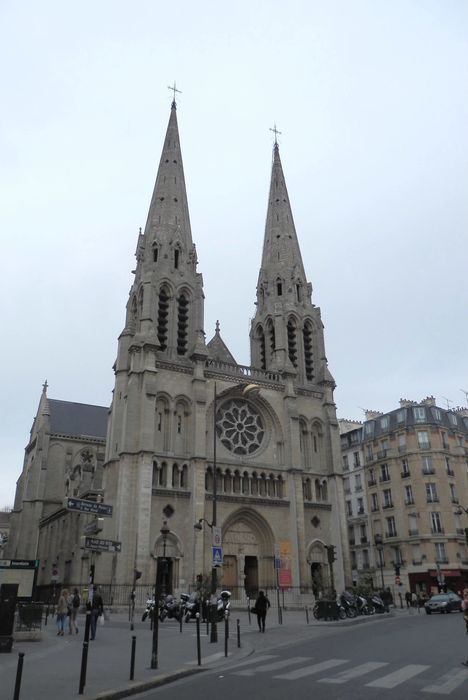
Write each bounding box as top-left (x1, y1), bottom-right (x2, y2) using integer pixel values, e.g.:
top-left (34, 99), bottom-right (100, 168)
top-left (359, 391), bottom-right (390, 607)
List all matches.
top-left (340, 396), bottom-right (468, 593)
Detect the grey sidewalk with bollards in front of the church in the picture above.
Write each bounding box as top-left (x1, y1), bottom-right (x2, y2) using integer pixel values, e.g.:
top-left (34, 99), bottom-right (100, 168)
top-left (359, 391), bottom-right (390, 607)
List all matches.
top-left (0, 609), bottom-right (396, 700)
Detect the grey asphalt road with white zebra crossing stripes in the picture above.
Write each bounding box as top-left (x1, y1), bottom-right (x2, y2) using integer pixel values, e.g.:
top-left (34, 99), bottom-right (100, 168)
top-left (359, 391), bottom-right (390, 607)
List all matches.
top-left (140, 614), bottom-right (468, 700)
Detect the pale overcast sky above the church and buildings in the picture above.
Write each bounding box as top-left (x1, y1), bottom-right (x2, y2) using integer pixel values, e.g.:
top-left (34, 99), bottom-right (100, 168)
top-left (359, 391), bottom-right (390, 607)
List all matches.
top-left (0, 0), bottom-right (468, 506)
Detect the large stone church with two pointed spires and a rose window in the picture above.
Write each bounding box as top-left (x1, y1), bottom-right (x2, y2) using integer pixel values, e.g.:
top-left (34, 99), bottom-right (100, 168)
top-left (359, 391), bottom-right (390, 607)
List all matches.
top-left (5, 101), bottom-right (350, 598)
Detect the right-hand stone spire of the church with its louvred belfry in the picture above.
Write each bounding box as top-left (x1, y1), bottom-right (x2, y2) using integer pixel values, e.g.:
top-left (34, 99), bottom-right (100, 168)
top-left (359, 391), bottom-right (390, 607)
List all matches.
top-left (250, 139), bottom-right (333, 385)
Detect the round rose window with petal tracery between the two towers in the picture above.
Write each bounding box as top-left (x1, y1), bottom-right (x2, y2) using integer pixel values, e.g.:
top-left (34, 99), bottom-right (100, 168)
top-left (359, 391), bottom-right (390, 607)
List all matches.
top-left (216, 399), bottom-right (265, 455)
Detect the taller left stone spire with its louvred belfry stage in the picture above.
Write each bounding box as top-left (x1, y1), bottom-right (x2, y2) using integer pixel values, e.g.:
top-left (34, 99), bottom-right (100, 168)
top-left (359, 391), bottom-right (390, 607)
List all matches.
top-left (119, 100), bottom-right (204, 361)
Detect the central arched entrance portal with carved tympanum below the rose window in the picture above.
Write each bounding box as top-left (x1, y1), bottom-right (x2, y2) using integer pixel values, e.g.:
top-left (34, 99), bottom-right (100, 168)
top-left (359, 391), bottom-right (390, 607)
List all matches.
top-left (222, 509), bottom-right (275, 598)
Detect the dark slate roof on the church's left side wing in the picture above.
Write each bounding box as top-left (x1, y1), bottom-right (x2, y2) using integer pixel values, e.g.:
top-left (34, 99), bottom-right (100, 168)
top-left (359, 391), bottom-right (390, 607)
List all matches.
top-left (48, 399), bottom-right (109, 438)
